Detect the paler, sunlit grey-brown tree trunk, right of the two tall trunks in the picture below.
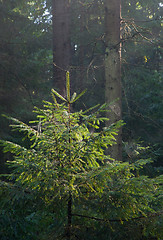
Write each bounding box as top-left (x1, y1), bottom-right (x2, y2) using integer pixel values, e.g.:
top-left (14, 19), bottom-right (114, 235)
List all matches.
top-left (105, 0), bottom-right (122, 160)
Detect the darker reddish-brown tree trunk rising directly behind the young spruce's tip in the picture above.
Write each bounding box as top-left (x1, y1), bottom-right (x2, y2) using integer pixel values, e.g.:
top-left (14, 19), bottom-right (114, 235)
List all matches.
top-left (52, 0), bottom-right (71, 96)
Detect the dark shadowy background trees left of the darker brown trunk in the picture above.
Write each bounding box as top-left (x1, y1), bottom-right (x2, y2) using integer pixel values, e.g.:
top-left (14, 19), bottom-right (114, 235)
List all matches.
top-left (0, 0), bottom-right (52, 171)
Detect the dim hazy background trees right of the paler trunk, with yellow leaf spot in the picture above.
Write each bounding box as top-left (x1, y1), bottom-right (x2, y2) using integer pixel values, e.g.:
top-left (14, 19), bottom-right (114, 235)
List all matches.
top-left (122, 1), bottom-right (162, 171)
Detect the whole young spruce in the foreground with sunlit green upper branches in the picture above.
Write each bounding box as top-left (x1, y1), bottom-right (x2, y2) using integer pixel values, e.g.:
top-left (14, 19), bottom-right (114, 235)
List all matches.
top-left (0, 72), bottom-right (161, 240)
